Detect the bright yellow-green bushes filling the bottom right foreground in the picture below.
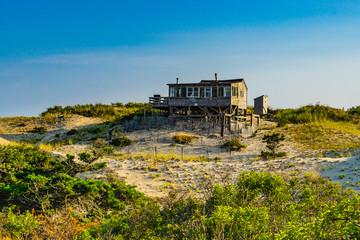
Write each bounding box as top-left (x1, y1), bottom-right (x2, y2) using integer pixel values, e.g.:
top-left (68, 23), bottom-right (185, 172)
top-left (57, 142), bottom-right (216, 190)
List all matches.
top-left (80, 172), bottom-right (360, 239)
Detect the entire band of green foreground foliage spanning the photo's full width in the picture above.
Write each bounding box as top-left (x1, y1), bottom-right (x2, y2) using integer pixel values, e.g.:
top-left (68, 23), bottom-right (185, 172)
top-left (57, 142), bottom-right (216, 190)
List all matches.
top-left (0, 146), bottom-right (360, 240)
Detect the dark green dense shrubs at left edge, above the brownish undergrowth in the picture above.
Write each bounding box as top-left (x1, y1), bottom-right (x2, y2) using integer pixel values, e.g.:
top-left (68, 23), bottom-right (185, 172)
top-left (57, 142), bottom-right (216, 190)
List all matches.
top-left (0, 146), bottom-right (142, 214)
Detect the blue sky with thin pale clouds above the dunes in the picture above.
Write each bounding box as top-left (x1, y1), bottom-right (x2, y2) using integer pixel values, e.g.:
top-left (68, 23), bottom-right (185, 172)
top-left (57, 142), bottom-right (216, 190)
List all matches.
top-left (0, 0), bottom-right (360, 116)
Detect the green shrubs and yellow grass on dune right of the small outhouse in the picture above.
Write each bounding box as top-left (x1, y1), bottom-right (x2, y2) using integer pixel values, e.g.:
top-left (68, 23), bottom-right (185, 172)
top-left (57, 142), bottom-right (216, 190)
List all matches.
top-left (276, 105), bottom-right (360, 151)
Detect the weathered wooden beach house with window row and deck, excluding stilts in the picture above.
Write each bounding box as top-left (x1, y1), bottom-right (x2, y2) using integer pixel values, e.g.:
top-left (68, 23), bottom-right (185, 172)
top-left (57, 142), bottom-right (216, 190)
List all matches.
top-left (150, 74), bottom-right (248, 117)
